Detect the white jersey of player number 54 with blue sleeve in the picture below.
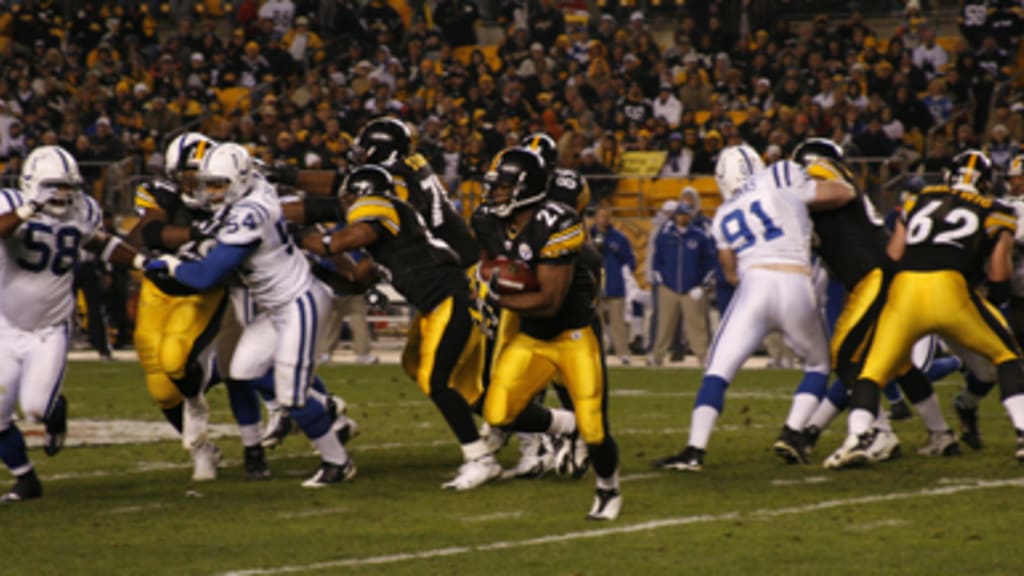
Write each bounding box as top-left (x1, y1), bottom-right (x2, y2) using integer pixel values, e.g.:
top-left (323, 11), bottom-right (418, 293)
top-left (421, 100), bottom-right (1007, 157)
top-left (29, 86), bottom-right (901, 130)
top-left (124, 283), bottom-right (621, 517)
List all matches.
top-left (221, 179), bottom-right (313, 310)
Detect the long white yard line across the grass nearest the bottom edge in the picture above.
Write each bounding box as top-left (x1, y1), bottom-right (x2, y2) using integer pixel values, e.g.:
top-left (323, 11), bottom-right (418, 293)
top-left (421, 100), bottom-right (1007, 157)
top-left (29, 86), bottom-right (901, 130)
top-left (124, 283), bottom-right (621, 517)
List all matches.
top-left (214, 478), bottom-right (1024, 576)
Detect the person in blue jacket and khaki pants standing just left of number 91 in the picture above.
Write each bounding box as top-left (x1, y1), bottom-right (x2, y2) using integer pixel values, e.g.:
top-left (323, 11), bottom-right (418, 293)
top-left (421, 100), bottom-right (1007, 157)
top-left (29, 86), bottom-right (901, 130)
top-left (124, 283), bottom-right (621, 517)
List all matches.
top-left (647, 202), bottom-right (717, 366)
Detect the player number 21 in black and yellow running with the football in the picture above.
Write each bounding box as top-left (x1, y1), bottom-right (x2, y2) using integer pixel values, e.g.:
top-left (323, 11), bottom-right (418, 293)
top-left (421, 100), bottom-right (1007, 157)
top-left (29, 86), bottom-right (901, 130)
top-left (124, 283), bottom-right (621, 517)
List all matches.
top-left (480, 148), bottom-right (623, 520)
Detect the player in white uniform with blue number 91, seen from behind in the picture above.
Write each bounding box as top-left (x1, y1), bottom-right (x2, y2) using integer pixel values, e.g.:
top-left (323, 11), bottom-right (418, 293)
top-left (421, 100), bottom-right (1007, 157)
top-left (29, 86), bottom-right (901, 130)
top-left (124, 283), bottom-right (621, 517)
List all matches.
top-left (653, 145), bottom-right (855, 470)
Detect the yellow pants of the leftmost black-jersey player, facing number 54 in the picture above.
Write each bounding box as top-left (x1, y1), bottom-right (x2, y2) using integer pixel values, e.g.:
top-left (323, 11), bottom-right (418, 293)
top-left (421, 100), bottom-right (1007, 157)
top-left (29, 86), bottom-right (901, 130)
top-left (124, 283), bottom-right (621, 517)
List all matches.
top-left (135, 279), bottom-right (225, 410)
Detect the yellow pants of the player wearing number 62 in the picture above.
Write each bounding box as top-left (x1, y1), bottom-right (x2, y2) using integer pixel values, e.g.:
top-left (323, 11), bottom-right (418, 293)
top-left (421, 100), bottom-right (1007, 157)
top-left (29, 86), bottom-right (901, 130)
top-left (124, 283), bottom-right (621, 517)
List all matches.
top-left (860, 271), bottom-right (1021, 386)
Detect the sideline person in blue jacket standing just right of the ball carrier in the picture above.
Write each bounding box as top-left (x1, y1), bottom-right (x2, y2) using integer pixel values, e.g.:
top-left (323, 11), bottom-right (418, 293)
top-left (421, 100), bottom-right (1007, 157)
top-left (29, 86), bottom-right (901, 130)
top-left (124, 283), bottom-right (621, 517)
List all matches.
top-left (590, 206), bottom-right (636, 364)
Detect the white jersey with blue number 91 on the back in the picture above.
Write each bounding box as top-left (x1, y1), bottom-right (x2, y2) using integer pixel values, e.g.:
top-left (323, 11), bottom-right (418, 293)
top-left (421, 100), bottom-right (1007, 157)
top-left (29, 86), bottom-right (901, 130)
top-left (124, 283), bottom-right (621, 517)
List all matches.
top-left (712, 160), bottom-right (815, 278)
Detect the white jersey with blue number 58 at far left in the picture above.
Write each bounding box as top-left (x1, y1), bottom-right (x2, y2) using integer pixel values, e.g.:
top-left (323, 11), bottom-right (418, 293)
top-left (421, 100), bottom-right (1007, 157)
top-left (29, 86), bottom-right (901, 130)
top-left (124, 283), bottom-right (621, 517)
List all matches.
top-left (0, 189), bottom-right (102, 330)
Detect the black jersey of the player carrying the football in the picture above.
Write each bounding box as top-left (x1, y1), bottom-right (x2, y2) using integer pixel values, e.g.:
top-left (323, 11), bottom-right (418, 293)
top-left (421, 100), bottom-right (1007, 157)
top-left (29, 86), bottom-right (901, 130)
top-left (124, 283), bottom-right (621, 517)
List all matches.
top-left (473, 200), bottom-right (600, 340)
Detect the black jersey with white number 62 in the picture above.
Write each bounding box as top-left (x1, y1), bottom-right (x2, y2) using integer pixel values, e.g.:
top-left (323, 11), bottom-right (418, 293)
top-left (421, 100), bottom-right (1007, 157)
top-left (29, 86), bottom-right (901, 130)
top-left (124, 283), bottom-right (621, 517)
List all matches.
top-left (900, 186), bottom-right (1017, 286)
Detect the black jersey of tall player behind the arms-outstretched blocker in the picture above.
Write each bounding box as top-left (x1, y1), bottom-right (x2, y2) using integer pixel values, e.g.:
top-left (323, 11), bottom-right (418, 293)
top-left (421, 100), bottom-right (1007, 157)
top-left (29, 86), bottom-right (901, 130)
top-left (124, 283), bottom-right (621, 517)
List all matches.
top-left (384, 154), bottom-right (480, 268)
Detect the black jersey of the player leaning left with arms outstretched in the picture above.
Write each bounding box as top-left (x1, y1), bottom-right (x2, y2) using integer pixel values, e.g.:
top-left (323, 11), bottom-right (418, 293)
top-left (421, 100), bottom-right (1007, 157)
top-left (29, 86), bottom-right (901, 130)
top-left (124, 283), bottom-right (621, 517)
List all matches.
top-left (347, 191), bottom-right (469, 314)
